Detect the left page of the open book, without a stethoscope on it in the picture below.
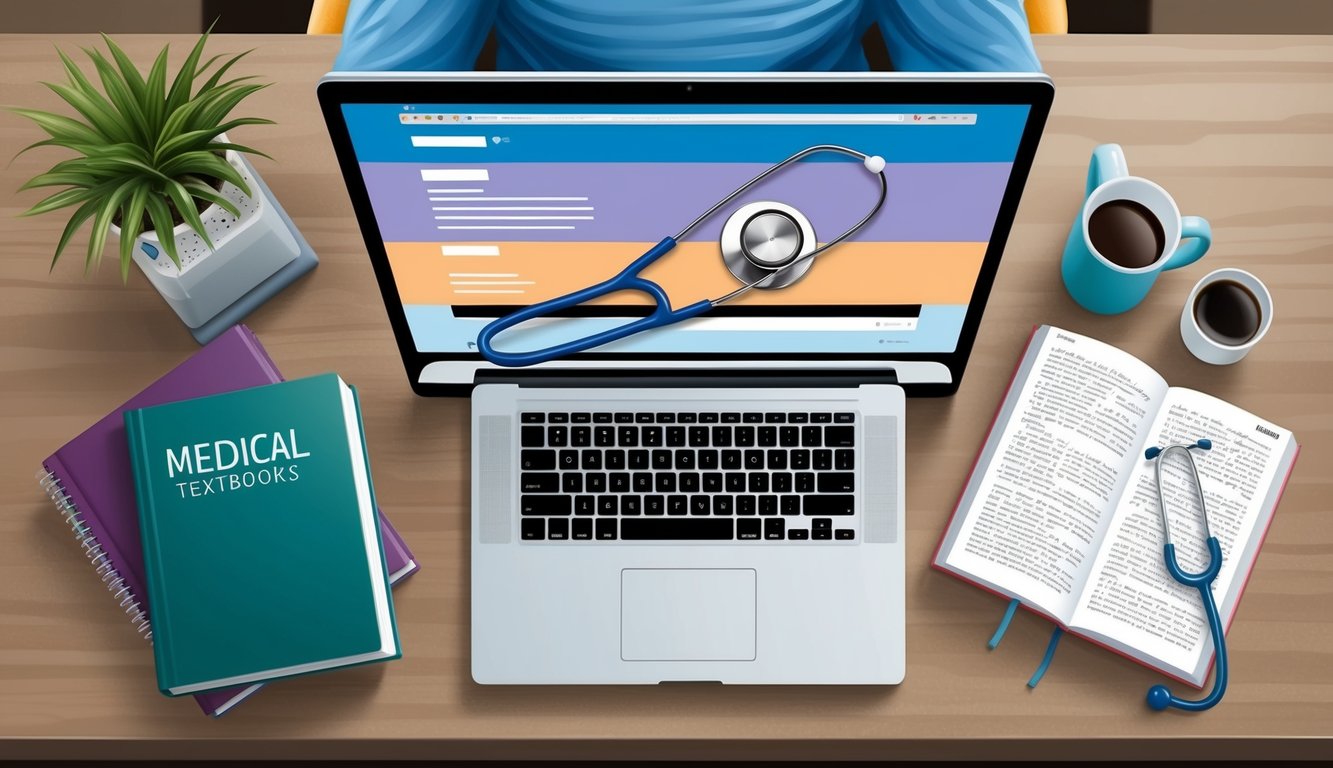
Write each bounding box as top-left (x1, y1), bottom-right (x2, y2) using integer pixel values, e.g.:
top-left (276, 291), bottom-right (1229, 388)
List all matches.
top-left (940, 328), bottom-right (1166, 623)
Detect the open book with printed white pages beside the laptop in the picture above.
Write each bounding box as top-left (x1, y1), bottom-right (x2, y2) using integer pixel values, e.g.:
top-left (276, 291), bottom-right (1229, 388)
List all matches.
top-left (934, 325), bottom-right (1300, 687)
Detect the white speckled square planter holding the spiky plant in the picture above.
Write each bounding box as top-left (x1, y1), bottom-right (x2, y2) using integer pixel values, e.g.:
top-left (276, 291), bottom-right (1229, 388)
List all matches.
top-left (112, 136), bottom-right (301, 329)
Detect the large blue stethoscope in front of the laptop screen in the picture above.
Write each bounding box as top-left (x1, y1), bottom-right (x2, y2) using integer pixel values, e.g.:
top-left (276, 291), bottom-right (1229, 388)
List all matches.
top-left (477, 144), bottom-right (889, 365)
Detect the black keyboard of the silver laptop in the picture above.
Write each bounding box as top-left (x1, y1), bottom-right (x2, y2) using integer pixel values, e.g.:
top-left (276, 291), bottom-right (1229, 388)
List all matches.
top-left (519, 411), bottom-right (857, 541)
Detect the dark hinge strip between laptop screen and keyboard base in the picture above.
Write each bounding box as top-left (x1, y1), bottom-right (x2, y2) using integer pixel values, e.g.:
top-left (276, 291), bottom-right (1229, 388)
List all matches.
top-left (476, 368), bottom-right (898, 388)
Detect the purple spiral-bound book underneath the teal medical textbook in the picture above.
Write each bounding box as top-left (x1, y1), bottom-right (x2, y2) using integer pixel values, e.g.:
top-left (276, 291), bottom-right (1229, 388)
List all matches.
top-left (39, 325), bottom-right (417, 717)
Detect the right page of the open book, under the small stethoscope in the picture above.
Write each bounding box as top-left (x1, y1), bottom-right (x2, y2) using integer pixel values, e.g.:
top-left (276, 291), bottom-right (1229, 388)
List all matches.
top-left (1074, 388), bottom-right (1294, 684)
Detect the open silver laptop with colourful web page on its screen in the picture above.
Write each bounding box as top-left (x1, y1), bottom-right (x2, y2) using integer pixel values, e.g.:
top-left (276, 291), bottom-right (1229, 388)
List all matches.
top-left (319, 73), bottom-right (1053, 684)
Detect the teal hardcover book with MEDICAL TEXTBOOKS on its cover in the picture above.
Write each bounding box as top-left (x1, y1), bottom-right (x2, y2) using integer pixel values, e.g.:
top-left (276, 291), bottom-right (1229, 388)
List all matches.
top-left (125, 373), bottom-right (401, 696)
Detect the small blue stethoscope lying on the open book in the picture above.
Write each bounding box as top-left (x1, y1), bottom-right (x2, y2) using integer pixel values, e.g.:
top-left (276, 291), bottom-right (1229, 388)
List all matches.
top-left (1144, 440), bottom-right (1226, 712)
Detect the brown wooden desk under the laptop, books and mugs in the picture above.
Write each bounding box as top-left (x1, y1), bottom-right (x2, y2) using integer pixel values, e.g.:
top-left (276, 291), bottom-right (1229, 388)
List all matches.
top-left (0, 36), bottom-right (1333, 759)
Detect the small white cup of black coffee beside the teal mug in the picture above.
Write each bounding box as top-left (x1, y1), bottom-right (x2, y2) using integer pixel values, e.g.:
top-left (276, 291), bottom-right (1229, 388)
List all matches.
top-left (1180, 269), bottom-right (1273, 365)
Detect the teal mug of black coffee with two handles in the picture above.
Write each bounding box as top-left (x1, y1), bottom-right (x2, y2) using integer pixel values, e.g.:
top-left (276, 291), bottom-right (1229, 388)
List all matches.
top-left (1060, 144), bottom-right (1213, 315)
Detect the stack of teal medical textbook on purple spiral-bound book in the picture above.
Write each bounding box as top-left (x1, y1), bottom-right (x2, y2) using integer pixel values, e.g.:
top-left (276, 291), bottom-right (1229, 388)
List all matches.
top-left (39, 325), bottom-right (417, 716)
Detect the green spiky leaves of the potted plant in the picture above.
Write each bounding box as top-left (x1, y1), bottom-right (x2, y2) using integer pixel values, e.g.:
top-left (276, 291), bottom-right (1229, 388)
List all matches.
top-left (12, 28), bottom-right (272, 280)
